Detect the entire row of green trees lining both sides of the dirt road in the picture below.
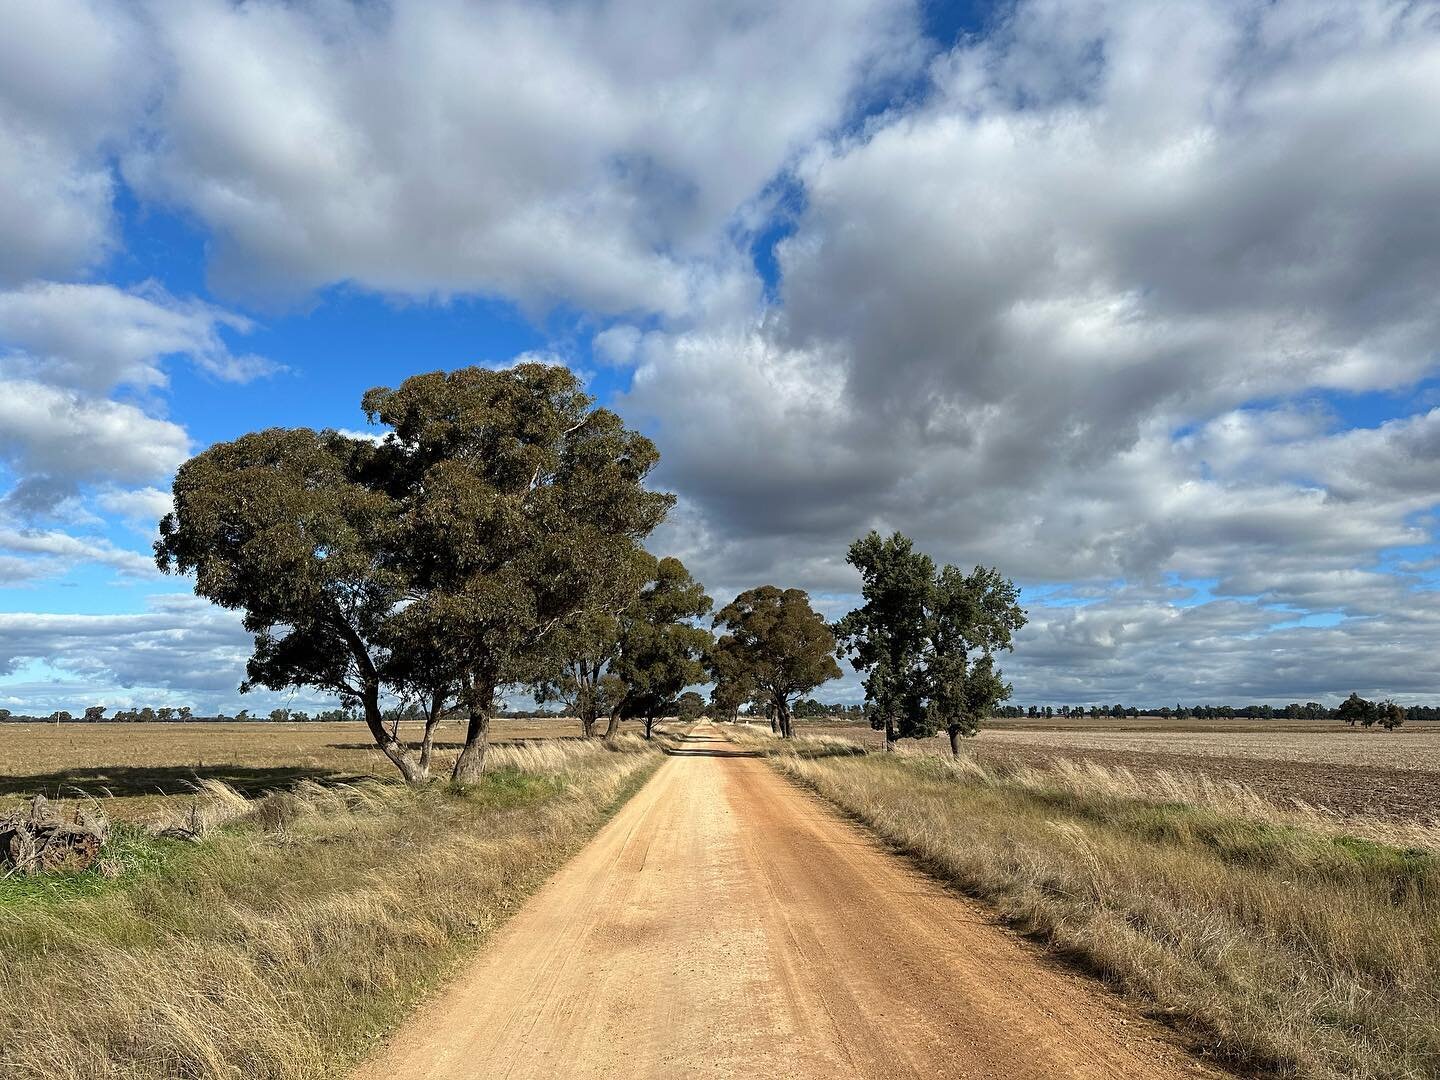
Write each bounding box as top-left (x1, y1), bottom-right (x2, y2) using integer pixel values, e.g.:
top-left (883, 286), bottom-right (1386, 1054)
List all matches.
top-left (156, 363), bottom-right (1025, 783)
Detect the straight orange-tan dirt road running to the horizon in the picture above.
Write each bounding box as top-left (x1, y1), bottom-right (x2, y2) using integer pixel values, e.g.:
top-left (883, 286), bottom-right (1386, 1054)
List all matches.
top-left (357, 724), bottom-right (1210, 1080)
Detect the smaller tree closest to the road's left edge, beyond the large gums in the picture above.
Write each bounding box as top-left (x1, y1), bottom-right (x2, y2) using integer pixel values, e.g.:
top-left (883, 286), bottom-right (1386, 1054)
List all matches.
top-left (605, 557), bottom-right (713, 739)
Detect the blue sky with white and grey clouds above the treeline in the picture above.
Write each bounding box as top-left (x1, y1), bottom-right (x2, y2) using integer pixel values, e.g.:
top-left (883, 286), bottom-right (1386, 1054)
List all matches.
top-left (0, 0), bottom-right (1440, 713)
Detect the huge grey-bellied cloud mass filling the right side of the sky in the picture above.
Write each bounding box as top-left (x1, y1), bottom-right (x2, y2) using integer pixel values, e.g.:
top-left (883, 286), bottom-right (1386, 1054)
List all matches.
top-left (606, 0), bottom-right (1440, 700)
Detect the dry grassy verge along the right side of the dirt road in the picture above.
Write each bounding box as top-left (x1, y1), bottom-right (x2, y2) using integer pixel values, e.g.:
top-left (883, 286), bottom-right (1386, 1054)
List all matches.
top-left (742, 734), bottom-right (1440, 1080)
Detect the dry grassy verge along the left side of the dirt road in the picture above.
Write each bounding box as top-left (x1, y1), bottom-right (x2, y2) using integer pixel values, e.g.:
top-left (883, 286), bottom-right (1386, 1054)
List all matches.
top-left (0, 740), bottom-right (660, 1080)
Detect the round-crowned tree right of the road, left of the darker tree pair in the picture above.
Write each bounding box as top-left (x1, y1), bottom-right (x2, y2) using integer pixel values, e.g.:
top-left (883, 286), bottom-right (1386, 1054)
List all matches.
top-left (714, 585), bottom-right (842, 739)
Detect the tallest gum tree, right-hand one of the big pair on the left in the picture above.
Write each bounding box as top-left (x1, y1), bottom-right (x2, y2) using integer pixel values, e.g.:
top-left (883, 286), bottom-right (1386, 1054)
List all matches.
top-left (363, 363), bottom-right (674, 783)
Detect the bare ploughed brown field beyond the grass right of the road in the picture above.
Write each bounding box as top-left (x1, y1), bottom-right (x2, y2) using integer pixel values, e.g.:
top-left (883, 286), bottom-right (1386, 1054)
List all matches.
top-left (802, 717), bottom-right (1440, 822)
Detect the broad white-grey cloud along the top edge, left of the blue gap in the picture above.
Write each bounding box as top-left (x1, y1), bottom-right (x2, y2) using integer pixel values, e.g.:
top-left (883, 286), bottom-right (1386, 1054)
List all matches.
top-left (124, 0), bottom-right (917, 314)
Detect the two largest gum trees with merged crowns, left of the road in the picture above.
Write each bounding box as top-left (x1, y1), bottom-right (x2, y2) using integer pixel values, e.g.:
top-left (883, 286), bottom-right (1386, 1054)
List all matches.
top-left (156, 363), bottom-right (672, 782)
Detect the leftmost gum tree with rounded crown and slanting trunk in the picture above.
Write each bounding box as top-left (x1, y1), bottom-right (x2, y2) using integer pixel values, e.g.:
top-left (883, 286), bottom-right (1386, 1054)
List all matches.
top-left (156, 428), bottom-right (423, 783)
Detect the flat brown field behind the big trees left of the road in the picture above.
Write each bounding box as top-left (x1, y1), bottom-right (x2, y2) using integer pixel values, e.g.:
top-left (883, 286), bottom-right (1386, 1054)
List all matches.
top-left (0, 719), bottom-right (641, 819)
